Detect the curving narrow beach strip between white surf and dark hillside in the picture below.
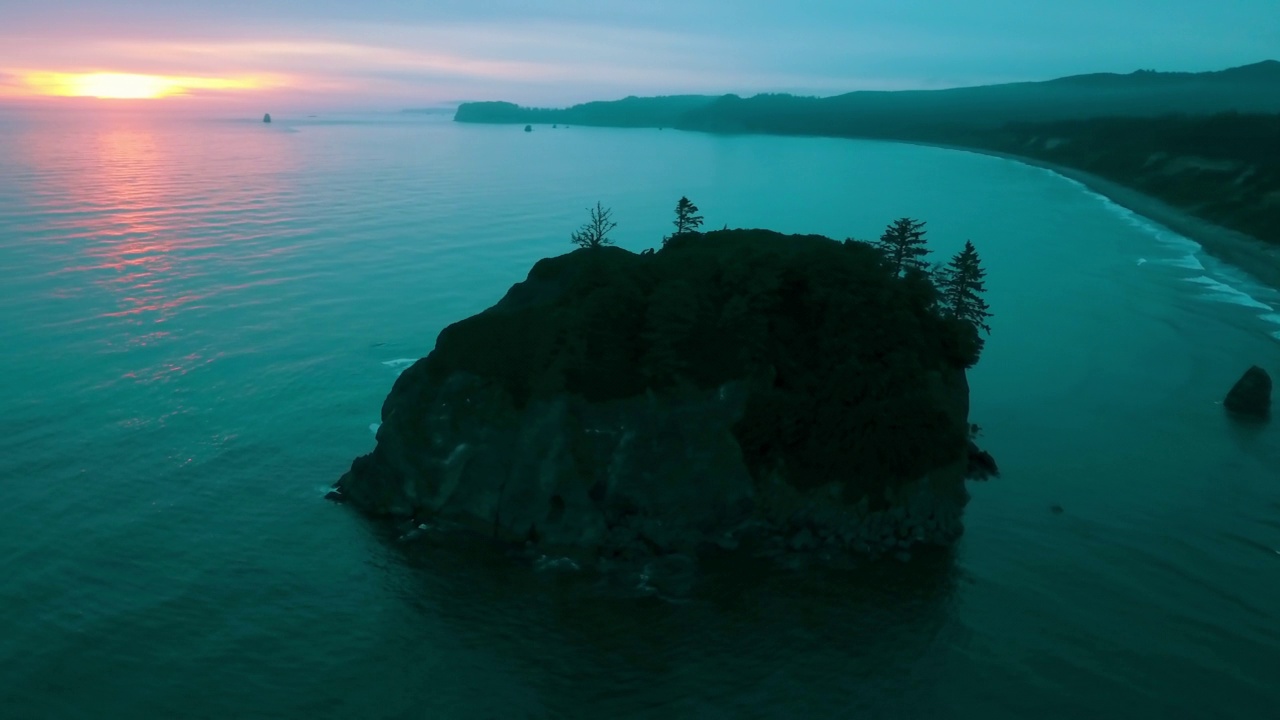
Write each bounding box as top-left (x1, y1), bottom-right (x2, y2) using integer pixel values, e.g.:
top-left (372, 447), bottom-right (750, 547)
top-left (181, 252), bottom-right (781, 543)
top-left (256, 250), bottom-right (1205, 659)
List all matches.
top-left (911, 142), bottom-right (1280, 290)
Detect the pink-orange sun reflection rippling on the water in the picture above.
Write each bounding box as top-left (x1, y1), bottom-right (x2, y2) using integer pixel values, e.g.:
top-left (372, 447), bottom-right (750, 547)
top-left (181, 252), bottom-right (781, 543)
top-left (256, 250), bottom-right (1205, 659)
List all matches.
top-left (23, 118), bottom-right (302, 382)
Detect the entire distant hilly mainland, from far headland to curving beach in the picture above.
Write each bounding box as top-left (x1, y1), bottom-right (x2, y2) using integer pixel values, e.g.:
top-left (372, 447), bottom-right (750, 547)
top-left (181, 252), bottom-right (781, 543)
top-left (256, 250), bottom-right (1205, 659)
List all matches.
top-left (454, 60), bottom-right (1280, 280)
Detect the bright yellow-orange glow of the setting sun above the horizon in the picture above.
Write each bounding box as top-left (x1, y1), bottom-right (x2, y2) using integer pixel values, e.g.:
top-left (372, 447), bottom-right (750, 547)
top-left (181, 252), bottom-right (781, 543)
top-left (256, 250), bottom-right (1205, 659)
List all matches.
top-left (24, 73), bottom-right (264, 100)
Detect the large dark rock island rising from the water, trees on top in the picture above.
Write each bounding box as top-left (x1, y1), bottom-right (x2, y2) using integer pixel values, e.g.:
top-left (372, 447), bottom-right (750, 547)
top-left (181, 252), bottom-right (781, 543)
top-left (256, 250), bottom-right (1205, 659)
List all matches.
top-left (334, 231), bottom-right (991, 559)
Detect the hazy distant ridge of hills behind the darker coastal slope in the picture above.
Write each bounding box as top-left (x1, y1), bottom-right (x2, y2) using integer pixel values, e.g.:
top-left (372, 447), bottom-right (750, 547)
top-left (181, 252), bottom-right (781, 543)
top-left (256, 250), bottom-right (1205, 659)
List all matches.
top-left (457, 60), bottom-right (1280, 128)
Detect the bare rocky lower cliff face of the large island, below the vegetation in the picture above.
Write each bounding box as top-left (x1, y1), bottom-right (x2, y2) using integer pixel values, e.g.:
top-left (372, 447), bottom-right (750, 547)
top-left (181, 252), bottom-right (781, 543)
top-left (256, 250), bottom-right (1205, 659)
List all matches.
top-left (337, 363), bottom-right (969, 556)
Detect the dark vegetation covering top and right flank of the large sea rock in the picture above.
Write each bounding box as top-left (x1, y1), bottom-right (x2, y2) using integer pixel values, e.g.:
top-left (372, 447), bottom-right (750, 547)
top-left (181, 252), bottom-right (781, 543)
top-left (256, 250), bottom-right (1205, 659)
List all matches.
top-left (409, 204), bottom-right (986, 492)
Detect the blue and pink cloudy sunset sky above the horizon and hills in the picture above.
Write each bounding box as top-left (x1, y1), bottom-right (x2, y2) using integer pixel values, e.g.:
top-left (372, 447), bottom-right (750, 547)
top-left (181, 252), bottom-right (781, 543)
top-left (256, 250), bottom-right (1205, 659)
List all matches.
top-left (0, 0), bottom-right (1280, 110)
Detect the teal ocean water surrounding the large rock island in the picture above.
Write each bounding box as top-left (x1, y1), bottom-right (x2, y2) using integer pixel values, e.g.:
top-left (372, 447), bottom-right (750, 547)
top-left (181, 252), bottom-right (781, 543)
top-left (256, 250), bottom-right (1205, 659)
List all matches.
top-left (0, 114), bottom-right (1280, 720)
